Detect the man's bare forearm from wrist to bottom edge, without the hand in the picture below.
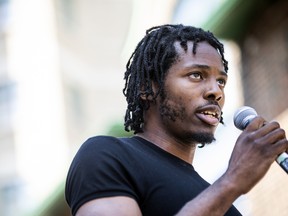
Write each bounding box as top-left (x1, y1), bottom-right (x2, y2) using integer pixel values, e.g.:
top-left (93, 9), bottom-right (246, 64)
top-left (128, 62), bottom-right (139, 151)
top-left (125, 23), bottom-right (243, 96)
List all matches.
top-left (177, 175), bottom-right (242, 216)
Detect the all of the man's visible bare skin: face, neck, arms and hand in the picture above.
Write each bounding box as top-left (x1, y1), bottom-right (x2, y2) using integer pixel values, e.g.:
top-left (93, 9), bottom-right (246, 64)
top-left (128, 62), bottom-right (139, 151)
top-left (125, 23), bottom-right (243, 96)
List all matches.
top-left (77, 42), bottom-right (288, 216)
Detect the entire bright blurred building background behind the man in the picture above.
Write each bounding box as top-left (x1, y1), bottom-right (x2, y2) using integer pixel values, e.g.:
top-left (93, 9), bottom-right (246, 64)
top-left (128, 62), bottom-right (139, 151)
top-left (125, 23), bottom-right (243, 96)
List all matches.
top-left (0, 0), bottom-right (288, 216)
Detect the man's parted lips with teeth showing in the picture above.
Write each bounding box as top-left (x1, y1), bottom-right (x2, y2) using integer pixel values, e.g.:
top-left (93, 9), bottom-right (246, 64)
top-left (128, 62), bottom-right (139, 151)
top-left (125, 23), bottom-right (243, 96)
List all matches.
top-left (196, 105), bottom-right (221, 126)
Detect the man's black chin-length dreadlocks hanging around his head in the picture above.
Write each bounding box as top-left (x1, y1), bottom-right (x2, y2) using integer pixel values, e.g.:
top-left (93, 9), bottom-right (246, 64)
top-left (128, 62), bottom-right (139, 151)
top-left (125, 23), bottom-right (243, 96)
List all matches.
top-left (123, 24), bottom-right (228, 134)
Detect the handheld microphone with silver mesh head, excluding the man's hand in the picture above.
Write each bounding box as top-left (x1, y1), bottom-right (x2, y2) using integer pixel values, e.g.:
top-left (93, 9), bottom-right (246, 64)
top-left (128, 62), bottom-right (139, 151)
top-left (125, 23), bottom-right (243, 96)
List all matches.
top-left (234, 106), bottom-right (288, 174)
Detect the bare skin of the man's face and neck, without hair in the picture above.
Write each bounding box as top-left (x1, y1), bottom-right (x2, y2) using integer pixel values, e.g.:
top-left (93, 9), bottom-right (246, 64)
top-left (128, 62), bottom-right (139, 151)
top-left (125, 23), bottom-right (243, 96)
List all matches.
top-left (139, 40), bottom-right (227, 163)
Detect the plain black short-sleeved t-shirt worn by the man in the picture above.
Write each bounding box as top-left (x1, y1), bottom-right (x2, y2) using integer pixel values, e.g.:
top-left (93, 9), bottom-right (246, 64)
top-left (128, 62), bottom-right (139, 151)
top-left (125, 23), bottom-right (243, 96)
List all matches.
top-left (65, 136), bottom-right (241, 216)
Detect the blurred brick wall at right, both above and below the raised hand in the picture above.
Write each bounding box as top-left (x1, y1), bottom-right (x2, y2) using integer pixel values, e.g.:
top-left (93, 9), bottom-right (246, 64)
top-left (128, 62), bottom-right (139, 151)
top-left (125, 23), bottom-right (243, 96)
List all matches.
top-left (241, 0), bottom-right (288, 216)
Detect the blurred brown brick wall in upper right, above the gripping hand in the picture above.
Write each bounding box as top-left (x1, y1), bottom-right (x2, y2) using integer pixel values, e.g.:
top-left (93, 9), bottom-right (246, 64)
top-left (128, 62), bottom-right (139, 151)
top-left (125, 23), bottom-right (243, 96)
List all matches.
top-left (242, 0), bottom-right (288, 120)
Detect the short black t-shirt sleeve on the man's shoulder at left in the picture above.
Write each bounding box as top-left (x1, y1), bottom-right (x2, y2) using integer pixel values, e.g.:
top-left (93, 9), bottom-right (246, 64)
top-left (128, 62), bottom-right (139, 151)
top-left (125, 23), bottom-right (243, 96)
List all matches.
top-left (65, 136), bottom-right (137, 215)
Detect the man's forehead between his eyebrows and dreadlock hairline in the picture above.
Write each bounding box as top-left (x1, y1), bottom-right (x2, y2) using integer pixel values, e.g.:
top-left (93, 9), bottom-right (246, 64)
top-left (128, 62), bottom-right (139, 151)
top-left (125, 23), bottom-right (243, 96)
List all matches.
top-left (174, 41), bottom-right (224, 71)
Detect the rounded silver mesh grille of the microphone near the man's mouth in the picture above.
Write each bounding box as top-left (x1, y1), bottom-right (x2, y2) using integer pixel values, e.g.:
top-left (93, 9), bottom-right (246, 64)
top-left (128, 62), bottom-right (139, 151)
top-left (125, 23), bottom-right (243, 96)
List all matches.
top-left (234, 106), bottom-right (257, 130)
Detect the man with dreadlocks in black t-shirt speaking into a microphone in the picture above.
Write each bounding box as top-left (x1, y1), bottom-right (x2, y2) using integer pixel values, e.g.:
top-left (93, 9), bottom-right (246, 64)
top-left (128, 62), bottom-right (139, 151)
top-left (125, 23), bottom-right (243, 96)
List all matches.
top-left (66, 25), bottom-right (288, 216)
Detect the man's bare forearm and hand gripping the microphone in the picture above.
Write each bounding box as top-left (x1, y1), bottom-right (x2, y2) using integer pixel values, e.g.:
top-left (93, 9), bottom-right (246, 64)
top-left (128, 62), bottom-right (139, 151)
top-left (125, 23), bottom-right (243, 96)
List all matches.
top-left (177, 117), bottom-right (288, 216)
